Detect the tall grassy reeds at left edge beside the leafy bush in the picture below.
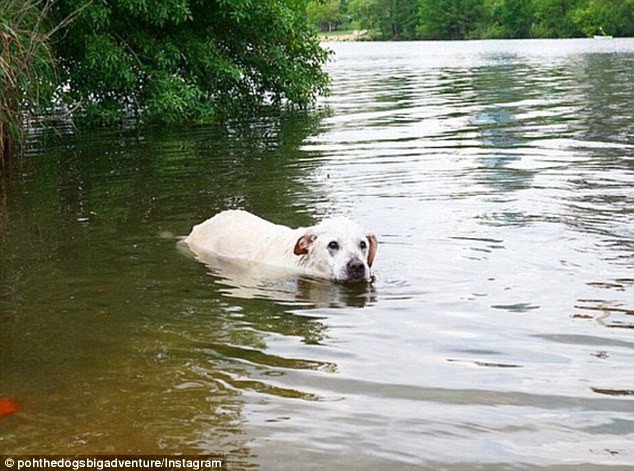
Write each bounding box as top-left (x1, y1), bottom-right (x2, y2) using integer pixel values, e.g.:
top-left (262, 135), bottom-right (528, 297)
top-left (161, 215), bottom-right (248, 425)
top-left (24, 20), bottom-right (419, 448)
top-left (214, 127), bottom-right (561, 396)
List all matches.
top-left (0, 0), bottom-right (55, 168)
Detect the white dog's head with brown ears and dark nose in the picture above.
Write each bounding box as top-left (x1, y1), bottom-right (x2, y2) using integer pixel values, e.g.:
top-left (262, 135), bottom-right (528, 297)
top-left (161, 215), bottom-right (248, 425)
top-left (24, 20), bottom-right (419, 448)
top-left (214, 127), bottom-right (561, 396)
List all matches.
top-left (293, 218), bottom-right (378, 281)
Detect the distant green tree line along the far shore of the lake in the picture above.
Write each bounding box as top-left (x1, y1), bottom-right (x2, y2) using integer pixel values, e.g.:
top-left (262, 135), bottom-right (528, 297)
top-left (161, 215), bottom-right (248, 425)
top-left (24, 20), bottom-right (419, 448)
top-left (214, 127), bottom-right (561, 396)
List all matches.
top-left (307, 0), bottom-right (634, 40)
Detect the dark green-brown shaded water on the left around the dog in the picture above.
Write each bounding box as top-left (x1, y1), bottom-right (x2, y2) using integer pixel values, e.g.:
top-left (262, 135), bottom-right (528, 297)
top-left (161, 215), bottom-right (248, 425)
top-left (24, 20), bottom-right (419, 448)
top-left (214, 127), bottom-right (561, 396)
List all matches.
top-left (0, 109), bottom-right (348, 463)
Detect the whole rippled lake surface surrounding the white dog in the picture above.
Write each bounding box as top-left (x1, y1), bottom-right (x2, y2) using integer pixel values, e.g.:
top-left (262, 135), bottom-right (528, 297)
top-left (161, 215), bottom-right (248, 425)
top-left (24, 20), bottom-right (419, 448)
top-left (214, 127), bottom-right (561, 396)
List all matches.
top-left (0, 39), bottom-right (634, 470)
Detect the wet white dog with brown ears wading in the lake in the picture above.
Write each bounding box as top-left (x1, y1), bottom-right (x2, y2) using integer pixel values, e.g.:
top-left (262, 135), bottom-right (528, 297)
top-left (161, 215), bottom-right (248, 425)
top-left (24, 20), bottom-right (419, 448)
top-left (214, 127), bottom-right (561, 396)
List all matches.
top-left (184, 210), bottom-right (378, 281)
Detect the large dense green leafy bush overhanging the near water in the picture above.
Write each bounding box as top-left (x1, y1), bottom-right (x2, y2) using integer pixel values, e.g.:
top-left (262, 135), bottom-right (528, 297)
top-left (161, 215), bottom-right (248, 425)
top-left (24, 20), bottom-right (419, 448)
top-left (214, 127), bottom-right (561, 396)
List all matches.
top-left (53, 0), bottom-right (328, 124)
